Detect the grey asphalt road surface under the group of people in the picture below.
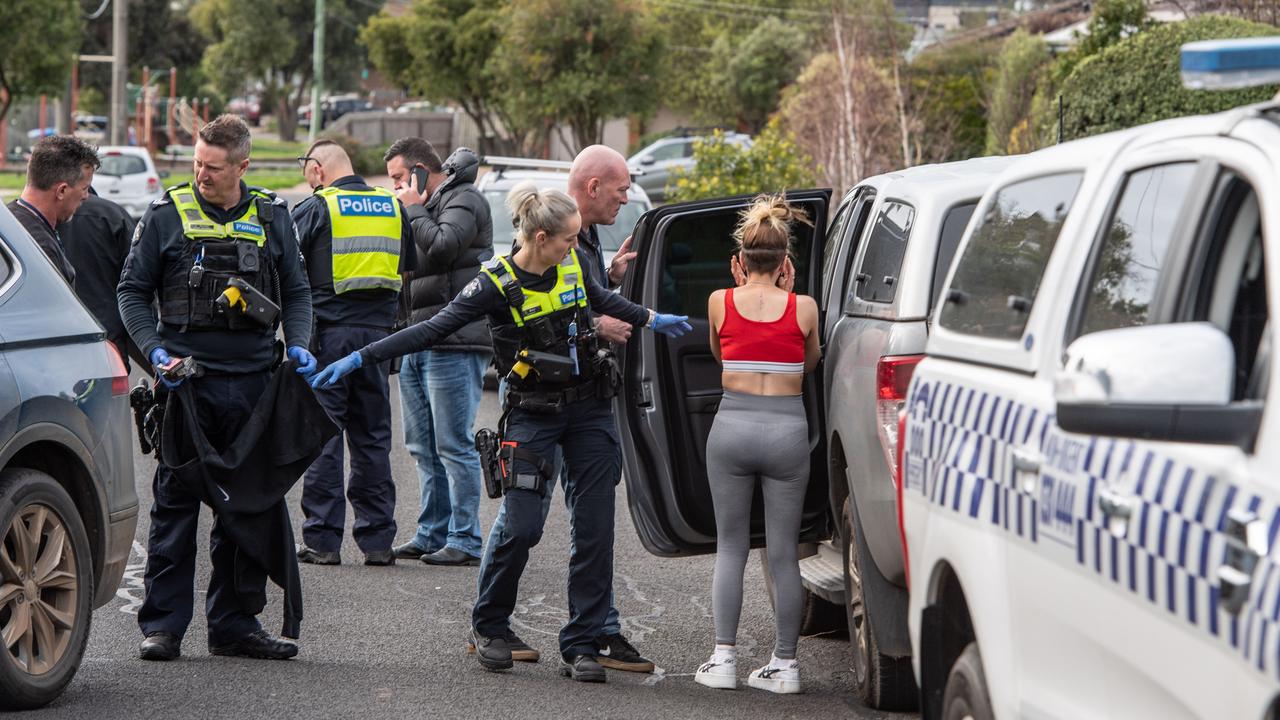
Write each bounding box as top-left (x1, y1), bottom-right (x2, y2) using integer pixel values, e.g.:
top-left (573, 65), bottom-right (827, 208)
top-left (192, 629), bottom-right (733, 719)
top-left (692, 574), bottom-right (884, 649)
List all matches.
top-left (15, 371), bottom-right (905, 720)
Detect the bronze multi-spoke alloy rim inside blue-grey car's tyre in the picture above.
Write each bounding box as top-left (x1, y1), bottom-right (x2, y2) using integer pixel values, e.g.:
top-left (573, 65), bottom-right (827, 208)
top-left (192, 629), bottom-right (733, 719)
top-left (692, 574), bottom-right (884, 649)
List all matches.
top-left (0, 502), bottom-right (79, 675)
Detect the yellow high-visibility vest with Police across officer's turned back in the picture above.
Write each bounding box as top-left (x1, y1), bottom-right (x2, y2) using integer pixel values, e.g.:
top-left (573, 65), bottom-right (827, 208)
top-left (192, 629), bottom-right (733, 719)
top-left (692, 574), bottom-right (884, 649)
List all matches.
top-left (317, 187), bottom-right (402, 295)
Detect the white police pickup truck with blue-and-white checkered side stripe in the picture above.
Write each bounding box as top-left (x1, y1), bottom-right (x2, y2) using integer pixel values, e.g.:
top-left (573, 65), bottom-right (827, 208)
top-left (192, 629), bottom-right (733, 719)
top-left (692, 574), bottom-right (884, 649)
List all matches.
top-left (899, 38), bottom-right (1280, 719)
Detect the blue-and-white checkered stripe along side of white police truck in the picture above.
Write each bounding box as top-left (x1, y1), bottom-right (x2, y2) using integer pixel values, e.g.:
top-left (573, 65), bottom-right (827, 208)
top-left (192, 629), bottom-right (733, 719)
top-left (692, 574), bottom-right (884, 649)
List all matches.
top-left (904, 378), bottom-right (1280, 678)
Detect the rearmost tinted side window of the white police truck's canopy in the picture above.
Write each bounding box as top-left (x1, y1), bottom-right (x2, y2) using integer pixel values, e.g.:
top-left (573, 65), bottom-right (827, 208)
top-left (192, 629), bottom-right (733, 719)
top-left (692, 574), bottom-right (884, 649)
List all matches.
top-left (938, 173), bottom-right (1082, 340)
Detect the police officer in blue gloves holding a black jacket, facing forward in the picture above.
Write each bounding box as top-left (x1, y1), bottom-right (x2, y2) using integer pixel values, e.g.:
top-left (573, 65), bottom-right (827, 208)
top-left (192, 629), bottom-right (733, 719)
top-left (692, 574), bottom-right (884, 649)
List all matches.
top-left (116, 115), bottom-right (316, 660)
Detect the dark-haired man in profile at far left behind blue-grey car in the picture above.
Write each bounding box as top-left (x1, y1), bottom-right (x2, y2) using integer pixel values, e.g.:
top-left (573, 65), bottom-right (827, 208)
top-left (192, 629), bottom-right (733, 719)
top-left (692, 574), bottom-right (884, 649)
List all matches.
top-left (9, 135), bottom-right (101, 284)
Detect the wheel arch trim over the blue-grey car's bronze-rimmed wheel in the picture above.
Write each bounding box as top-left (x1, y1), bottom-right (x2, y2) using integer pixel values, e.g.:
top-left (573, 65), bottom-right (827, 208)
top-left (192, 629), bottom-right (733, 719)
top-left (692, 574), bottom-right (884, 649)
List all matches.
top-left (0, 424), bottom-right (108, 580)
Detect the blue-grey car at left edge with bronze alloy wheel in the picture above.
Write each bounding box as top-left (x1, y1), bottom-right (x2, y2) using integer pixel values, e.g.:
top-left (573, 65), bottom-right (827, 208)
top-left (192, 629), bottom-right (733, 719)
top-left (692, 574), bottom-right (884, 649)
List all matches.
top-left (0, 199), bottom-right (138, 710)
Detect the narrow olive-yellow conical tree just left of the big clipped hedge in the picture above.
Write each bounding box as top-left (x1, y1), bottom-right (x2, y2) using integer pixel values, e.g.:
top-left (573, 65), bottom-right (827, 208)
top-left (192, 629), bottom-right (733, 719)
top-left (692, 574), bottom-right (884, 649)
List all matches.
top-left (987, 29), bottom-right (1050, 155)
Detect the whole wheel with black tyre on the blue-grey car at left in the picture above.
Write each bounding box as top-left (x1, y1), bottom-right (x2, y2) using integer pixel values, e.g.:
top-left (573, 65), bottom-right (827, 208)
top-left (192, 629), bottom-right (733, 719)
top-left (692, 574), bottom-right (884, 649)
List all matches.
top-left (0, 468), bottom-right (93, 710)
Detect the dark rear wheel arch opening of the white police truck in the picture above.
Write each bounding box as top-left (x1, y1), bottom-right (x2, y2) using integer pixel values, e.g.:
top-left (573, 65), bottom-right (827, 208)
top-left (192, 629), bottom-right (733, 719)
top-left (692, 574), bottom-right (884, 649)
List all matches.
top-left (916, 560), bottom-right (980, 720)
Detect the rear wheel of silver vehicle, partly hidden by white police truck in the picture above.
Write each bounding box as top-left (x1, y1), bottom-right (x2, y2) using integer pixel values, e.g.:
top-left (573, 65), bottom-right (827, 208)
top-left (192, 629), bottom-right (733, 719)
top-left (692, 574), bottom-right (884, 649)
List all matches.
top-left (840, 498), bottom-right (918, 710)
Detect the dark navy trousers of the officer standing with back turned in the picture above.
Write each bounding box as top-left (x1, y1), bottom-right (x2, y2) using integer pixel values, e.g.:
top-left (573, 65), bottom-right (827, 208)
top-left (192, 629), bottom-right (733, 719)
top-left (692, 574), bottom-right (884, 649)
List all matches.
top-left (302, 325), bottom-right (396, 552)
